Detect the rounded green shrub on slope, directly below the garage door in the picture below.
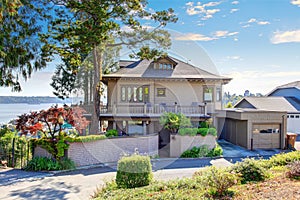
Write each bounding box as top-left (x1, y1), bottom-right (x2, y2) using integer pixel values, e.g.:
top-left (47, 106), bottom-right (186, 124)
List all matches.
top-left (232, 158), bottom-right (268, 184)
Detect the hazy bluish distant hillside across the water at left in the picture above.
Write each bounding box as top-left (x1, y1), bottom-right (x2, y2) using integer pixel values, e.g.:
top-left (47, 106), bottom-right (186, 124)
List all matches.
top-left (0, 96), bottom-right (81, 104)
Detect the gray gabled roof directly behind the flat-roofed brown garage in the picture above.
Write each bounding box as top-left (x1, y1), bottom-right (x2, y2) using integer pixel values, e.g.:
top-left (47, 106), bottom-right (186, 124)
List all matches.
top-left (234, 97), bottom-right (300, 112)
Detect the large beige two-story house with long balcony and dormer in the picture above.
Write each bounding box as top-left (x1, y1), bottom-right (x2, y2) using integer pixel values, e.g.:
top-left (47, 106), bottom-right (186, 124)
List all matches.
top-left (100, 56), bottom-right (231, 135)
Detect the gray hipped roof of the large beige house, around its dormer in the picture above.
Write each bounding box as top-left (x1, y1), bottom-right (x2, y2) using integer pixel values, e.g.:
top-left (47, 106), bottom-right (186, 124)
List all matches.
top-left (103, 56), bottom-right (231, 84)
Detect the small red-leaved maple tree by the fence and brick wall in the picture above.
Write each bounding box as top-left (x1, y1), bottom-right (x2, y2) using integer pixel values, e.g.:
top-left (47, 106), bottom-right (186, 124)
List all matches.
top-left (16, 105), bottom-right (89, 160)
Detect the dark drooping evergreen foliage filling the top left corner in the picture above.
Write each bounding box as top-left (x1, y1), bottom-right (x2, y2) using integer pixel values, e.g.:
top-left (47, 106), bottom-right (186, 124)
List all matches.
top-left (0, 0), bottom-right (50, 92)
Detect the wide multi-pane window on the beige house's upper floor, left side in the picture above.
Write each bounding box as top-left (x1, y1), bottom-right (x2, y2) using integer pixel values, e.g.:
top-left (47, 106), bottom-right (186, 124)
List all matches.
top-left (121, 85), bottom-right (149, 102)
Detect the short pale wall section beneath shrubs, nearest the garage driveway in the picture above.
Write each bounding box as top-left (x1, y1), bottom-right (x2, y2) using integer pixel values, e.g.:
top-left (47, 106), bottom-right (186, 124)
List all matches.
top-left (170, 135), bottom-right (216, 158)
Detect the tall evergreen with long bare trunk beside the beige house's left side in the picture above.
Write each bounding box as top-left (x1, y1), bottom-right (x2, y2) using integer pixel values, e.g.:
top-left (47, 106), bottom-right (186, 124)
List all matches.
top-left (49, 0), bottom-right (177, 132)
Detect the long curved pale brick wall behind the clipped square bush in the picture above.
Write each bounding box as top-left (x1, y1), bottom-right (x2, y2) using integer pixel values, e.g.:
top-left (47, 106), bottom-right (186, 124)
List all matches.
top-left (68, 135), bottom-right (158, 166)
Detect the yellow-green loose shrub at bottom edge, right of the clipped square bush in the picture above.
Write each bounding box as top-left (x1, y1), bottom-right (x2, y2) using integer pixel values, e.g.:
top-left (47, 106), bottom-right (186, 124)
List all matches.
top-left (194, 166), bottom-right (240, 199)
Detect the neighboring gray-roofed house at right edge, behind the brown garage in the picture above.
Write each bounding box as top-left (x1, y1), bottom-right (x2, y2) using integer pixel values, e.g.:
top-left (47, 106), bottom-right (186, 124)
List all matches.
top-left (234, 81), bottom-right (300, 134)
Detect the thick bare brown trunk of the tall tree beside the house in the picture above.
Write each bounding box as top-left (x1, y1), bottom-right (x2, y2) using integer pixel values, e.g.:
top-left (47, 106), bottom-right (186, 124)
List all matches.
top-left (90, 47), bottom-right (102, 134)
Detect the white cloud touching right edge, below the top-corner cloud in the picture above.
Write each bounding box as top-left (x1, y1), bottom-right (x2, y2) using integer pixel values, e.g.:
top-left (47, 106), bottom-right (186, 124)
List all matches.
top-left (271, 30), bottom-right (300, 44)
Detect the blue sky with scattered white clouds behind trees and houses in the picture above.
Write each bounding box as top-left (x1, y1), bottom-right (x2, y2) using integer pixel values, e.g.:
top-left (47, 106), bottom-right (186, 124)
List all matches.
top-left (0, 0), bottom-right (300, 96)
